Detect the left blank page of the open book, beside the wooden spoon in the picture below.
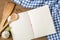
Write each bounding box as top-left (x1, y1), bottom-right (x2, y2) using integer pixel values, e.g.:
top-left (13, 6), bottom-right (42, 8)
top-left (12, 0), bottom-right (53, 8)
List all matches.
top-left (10, 12), bottom-right (33, 40)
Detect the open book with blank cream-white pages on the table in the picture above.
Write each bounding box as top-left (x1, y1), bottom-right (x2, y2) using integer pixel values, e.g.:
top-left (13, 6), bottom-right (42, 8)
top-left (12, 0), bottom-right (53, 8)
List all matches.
top-left (10, 5), bottom-right (56, 40)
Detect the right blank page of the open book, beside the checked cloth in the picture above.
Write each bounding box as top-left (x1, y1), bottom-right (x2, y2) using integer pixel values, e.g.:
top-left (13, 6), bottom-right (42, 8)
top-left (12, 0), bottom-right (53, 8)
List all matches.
top-left (28, 5), bottom-right (56, 38)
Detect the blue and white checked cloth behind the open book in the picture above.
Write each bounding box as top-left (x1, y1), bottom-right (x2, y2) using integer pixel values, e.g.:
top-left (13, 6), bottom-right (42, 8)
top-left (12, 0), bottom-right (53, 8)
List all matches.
top-left (13, 0), bottom-right (60, 40)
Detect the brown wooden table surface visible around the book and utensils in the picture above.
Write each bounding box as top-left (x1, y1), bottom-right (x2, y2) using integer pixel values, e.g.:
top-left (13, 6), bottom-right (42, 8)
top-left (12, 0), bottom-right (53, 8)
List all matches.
top-left (0, 0), bottom-right (47, 40)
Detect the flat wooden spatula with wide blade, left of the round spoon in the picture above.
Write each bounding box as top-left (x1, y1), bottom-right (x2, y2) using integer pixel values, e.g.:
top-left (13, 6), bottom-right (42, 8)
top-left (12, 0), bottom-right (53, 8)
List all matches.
top-left (0, 3), bottom-right (15, 33)
